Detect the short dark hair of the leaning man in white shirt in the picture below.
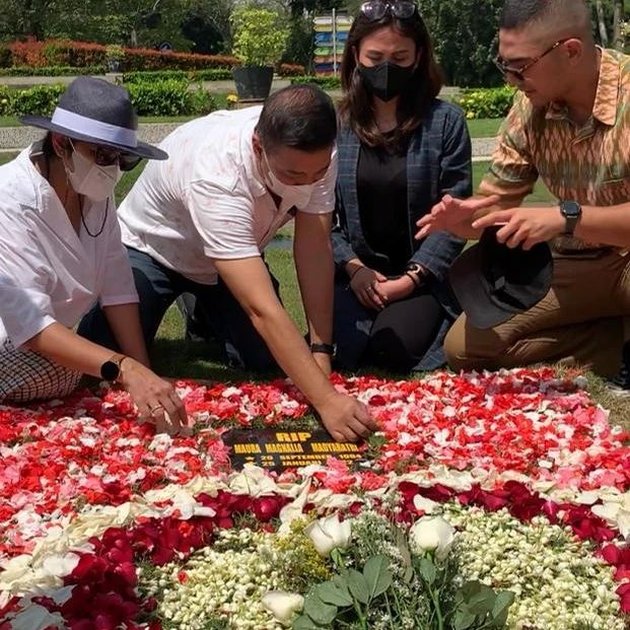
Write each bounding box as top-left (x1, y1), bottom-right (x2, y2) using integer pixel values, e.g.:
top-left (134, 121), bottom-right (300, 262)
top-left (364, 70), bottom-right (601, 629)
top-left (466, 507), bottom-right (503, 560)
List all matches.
top-left (256, 84), bottom-right (337, 152)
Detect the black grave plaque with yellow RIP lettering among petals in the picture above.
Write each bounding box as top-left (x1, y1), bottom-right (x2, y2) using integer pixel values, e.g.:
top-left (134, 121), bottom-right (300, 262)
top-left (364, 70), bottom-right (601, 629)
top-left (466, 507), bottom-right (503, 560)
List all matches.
top-left (221, 429), bottom-right (362, 471)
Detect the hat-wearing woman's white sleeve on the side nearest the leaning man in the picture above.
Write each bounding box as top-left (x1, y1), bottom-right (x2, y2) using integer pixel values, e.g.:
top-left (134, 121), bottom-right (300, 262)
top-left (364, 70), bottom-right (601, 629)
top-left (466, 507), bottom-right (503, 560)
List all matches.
top-left (99, 206), bottom-right (139, 306)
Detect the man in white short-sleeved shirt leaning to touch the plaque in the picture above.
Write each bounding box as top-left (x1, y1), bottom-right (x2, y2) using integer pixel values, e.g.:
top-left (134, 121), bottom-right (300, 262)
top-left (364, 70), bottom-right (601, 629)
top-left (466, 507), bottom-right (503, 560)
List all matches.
top-left (82, 85), bottom-right (376, 440)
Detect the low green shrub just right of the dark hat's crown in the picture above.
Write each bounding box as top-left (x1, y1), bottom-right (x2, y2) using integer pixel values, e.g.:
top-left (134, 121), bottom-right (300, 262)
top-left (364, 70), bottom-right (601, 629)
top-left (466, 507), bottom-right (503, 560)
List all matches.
top-left (127, 79), bottom-right (215, 116)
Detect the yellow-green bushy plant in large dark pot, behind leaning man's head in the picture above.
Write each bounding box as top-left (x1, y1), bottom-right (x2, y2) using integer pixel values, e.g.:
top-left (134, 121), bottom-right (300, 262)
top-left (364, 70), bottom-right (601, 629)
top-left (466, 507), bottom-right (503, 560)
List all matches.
top-left (230, 5), bottom-right (289, 100)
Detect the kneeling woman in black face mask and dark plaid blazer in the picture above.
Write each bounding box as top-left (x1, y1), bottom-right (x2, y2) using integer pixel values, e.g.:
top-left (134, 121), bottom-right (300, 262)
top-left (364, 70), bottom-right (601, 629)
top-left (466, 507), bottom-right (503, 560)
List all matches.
top-left (333, 0), bottom-right (471, 372)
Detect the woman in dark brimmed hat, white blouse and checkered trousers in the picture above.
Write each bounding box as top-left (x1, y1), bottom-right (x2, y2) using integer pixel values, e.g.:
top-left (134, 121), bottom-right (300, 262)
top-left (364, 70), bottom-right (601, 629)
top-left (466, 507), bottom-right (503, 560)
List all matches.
top-left (0, 77), bottom-right (187, 432)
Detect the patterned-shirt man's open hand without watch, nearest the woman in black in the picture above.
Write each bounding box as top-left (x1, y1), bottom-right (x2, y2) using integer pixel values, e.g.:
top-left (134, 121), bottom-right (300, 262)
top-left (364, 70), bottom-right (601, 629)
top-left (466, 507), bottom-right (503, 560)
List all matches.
top-left (416, 195), bottom-right (500, 240)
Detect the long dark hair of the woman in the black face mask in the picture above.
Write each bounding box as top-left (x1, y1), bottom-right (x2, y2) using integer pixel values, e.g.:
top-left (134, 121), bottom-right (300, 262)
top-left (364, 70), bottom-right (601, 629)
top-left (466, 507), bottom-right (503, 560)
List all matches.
top-left (339, 9), bottom-right (443, 147)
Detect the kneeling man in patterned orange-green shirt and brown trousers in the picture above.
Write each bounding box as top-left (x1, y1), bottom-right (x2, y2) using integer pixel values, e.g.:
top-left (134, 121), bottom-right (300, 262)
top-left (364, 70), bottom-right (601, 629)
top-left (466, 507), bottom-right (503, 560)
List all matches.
top-left (417, 0), bottom-right (630, 390)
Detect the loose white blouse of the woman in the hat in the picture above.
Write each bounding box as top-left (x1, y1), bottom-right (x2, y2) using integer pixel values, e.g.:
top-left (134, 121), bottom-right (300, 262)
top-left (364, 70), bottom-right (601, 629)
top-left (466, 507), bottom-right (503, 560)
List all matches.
top-left (0, 142), bottom-right (138, 348)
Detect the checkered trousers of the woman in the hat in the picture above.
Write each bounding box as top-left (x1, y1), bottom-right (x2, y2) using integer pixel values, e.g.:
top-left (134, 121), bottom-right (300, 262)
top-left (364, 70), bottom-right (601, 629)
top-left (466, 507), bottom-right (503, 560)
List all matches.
top-left (0, 340), bottom-right (83, 403)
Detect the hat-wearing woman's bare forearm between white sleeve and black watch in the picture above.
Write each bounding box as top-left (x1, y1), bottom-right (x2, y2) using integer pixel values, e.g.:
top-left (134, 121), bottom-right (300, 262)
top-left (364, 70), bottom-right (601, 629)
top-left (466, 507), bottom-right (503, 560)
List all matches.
top-left (24, 323), bottom-right (114, 377)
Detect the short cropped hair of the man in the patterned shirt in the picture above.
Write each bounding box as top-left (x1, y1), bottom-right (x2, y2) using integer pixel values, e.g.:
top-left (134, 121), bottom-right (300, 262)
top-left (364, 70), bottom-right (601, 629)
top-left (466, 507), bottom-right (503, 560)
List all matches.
top-left (499, 0), bottom-right (590, 35)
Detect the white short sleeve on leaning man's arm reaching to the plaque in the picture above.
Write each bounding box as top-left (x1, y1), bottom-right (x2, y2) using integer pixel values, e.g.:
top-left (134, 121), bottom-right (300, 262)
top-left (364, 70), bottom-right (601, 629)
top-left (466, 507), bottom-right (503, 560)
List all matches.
top-left (188, 177), bottom-right (260, 260)
